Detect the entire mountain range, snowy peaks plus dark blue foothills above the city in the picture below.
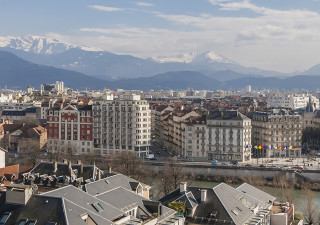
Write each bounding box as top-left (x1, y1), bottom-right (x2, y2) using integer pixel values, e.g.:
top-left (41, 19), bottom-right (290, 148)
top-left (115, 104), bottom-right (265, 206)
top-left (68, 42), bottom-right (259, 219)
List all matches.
top-left (0, 36), bottom-right (320, 90)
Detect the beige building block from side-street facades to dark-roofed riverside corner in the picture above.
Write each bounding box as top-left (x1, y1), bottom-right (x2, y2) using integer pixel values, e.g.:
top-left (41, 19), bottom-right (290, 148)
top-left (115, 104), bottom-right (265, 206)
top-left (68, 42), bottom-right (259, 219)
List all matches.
top-left (155, 107), bottom-right (251, 161)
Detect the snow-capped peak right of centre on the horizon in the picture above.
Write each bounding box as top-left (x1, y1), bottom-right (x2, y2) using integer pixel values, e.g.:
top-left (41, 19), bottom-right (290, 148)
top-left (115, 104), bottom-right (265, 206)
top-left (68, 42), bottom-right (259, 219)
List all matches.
top-left (152, 51), bottom-right (233, 63)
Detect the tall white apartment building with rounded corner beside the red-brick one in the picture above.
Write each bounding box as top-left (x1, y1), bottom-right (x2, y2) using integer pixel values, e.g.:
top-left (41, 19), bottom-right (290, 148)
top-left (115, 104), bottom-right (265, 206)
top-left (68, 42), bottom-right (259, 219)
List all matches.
top-left (93, 94), bottom-right (151, 157)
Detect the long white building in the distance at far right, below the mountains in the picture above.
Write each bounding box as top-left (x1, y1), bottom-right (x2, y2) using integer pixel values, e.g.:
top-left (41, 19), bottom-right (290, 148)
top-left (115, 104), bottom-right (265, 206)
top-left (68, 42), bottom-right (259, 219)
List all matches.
top-left (267, 93), bottom-right (319, 110)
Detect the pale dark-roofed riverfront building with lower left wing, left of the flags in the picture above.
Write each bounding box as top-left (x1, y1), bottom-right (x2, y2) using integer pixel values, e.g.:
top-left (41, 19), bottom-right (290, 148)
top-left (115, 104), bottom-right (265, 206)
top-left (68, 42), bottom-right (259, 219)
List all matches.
top-left (183, 111), bottom-right (251, 161)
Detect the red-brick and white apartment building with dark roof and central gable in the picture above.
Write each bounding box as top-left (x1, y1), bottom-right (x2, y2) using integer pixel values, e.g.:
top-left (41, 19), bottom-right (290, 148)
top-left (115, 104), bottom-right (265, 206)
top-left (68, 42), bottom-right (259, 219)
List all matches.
top-left (47, 105), bottom-right (93, 154)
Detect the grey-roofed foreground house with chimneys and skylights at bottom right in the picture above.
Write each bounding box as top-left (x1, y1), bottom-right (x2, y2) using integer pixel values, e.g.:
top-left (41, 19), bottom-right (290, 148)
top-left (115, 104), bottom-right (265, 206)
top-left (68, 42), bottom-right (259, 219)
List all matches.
top-left (159, 183), bottom-right (294, 225)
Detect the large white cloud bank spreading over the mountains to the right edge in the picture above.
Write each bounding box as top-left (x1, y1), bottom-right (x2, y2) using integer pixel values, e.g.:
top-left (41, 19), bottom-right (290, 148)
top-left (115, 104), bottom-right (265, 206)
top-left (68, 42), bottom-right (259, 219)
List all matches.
top-left (50, 0), bottom-right (320, 72)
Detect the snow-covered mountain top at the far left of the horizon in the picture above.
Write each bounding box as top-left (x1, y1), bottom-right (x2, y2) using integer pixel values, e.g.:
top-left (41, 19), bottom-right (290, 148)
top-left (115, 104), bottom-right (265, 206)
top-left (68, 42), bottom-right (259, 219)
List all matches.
top-left (0, 35), bottom-right (96, 55)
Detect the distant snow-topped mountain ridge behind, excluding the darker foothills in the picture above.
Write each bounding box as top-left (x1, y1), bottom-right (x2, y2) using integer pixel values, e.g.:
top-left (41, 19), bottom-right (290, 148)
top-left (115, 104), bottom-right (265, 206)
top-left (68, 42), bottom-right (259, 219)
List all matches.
top-left (0, 36), bottom-right (284, 80)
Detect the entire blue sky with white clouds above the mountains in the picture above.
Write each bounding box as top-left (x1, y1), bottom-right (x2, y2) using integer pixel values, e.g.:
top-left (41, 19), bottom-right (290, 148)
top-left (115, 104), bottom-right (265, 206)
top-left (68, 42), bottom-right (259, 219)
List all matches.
top-left (0, 0), bottom-right (320, 73)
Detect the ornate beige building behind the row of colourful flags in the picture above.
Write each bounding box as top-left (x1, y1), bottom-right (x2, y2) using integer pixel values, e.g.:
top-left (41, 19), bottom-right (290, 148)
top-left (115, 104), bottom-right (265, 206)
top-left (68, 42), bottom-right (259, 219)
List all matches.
top-left (252, 109), bottom-right (302, 157)
